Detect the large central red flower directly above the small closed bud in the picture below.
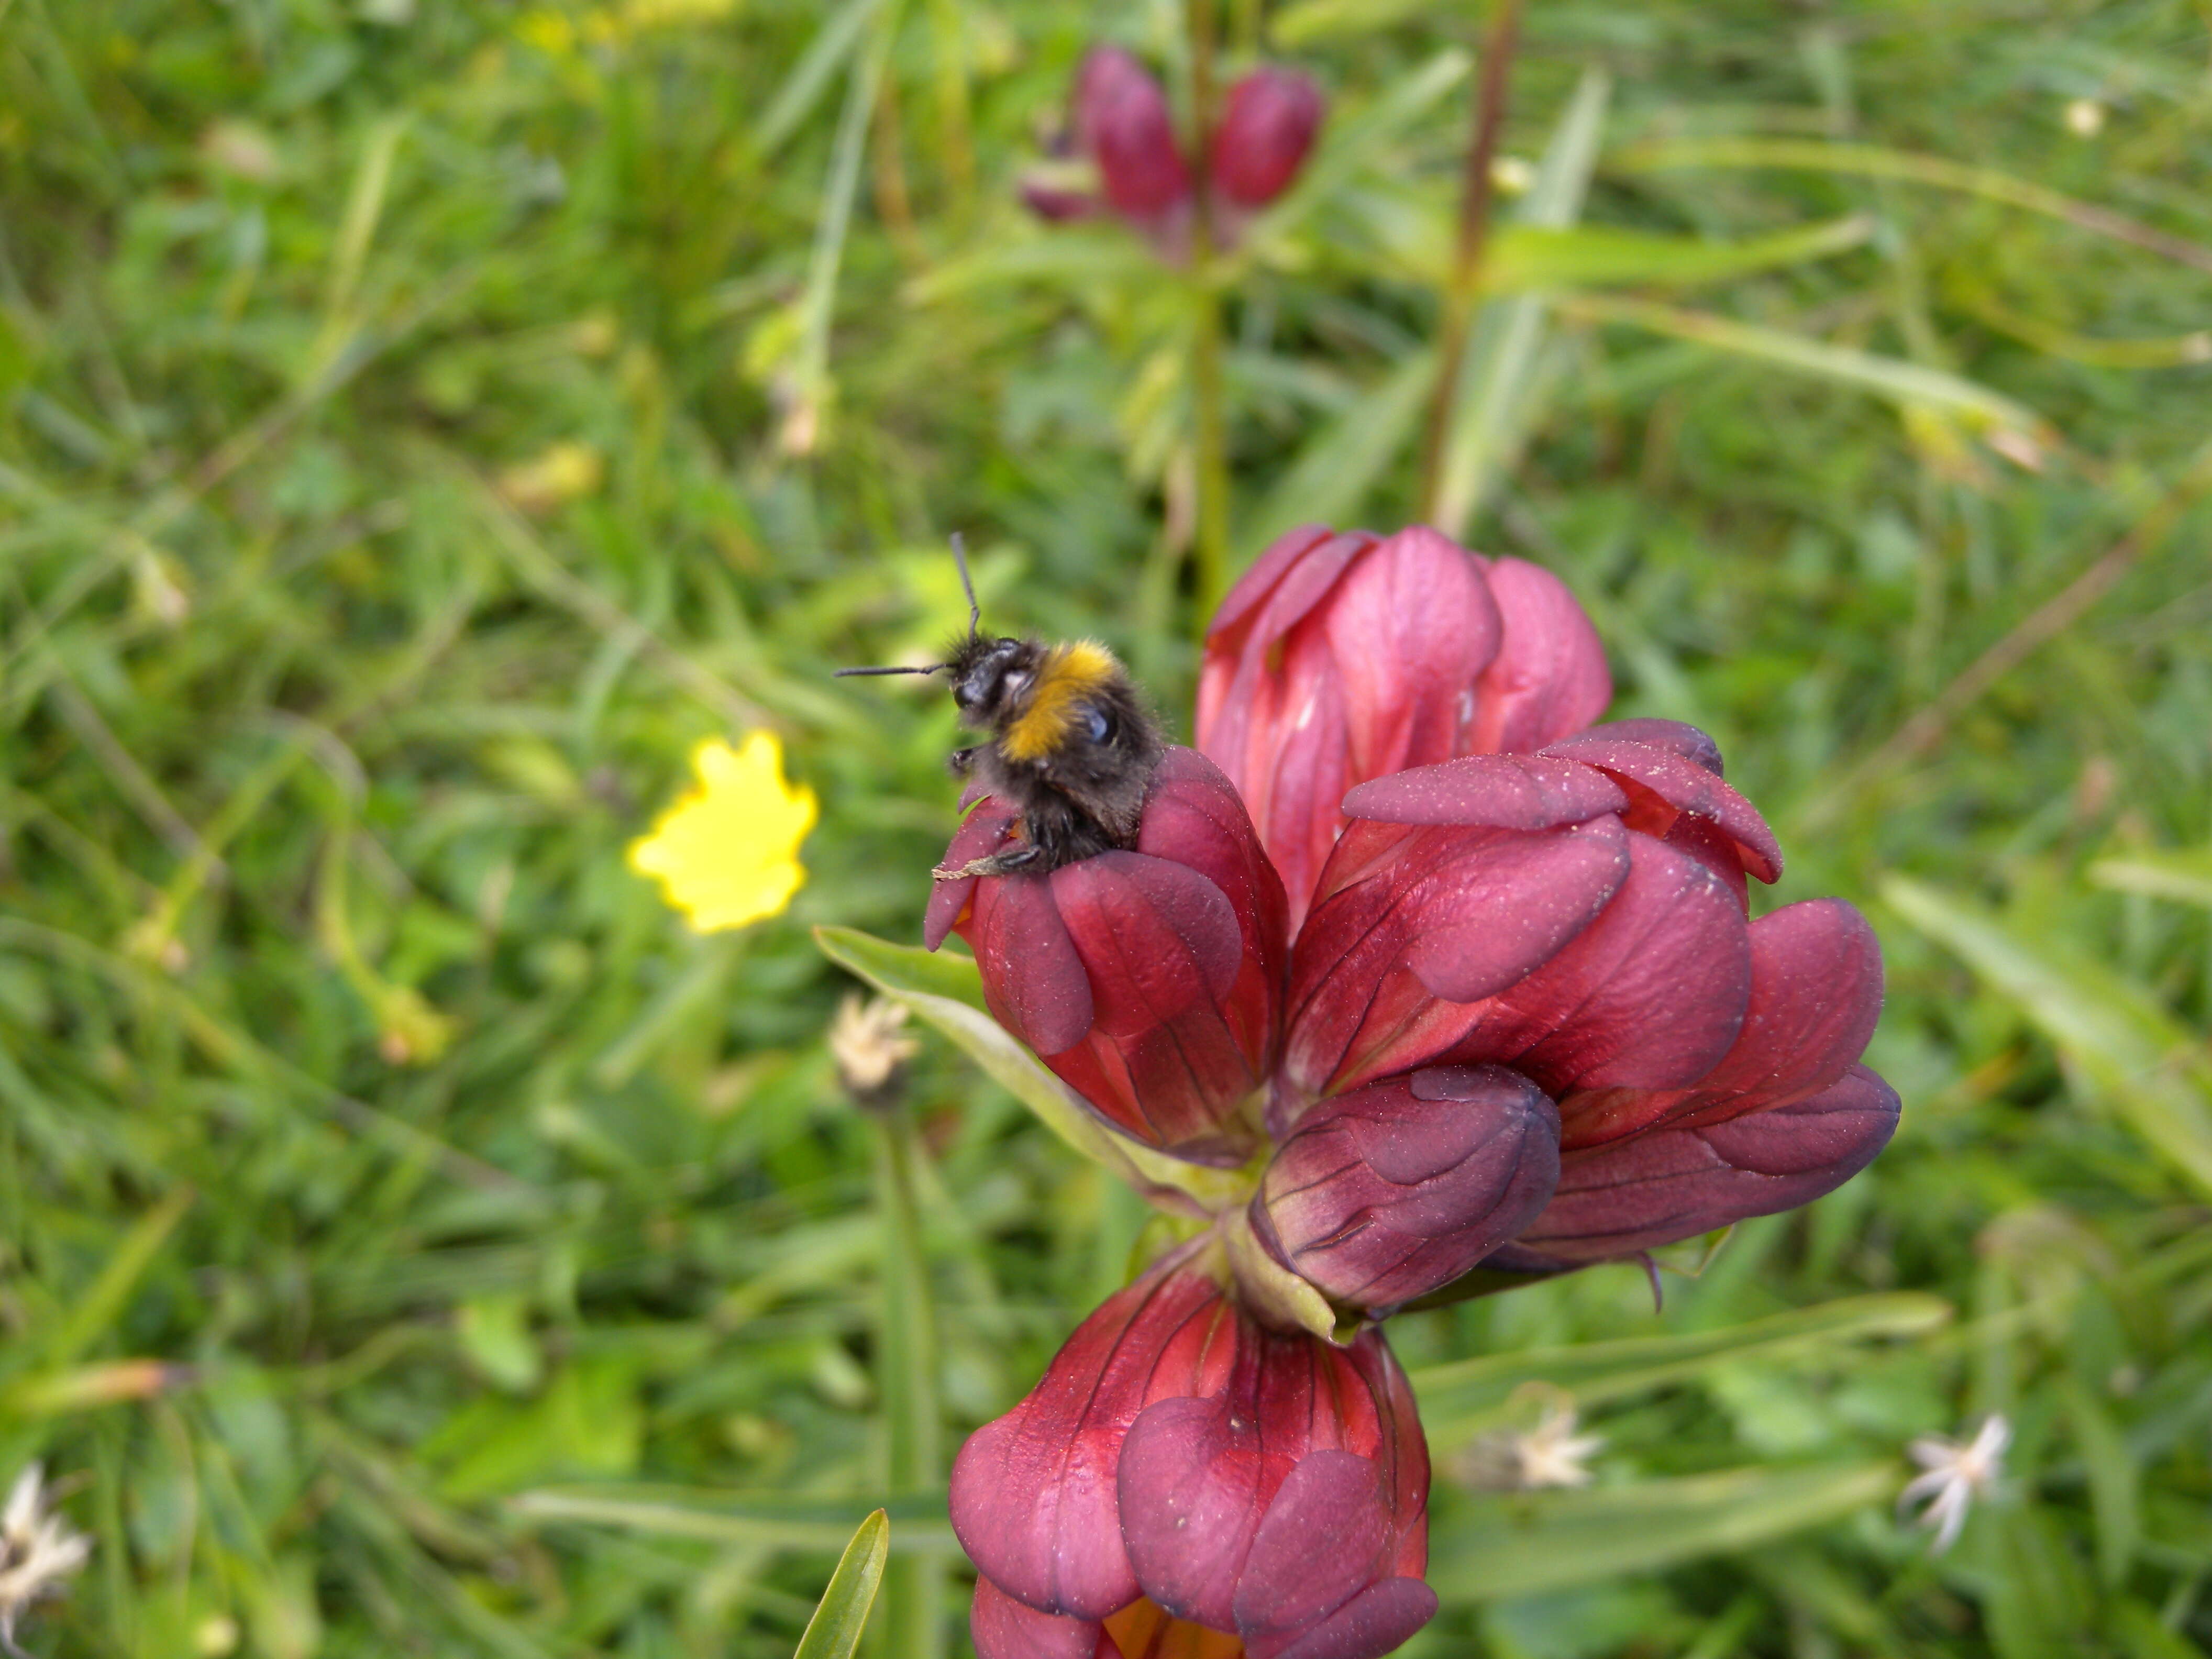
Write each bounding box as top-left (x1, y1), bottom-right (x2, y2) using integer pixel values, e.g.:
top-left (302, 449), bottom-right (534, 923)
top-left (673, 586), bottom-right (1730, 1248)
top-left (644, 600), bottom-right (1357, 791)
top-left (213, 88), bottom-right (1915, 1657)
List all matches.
top-left (1274, 743), bottom-right (1767, 1119)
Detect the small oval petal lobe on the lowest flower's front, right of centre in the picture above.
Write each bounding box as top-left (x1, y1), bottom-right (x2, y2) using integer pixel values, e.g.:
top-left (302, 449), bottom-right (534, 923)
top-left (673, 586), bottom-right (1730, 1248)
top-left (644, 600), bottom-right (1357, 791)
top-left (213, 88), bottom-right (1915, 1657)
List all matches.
top-left (1236, 1451), bottom-right (1393, 1652)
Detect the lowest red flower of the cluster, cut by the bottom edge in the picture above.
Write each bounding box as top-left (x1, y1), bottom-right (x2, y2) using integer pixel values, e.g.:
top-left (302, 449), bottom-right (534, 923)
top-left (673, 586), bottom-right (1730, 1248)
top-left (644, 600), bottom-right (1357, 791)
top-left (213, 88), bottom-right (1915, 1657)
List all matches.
top-left (951, 1238), bottom-right (1435, 1659)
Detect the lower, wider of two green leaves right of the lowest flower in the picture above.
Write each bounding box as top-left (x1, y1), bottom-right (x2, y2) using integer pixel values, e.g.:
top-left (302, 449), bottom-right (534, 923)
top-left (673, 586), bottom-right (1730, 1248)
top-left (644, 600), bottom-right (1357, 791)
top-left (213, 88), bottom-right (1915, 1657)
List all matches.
top-left (1429, 1462), bottom-right (1900, 1601)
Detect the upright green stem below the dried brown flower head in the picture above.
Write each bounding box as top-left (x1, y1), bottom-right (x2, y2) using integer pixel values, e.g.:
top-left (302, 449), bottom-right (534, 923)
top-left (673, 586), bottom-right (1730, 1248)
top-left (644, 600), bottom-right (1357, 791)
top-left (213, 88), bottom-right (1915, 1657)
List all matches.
top-left (876, 1104), bottom-right (945, 1659)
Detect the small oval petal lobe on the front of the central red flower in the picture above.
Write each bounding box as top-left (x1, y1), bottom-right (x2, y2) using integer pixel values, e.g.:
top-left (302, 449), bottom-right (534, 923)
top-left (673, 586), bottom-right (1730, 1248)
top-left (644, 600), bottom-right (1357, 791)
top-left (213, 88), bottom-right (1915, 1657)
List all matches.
top-left (1404, 819), bottom-right (1628, 1002)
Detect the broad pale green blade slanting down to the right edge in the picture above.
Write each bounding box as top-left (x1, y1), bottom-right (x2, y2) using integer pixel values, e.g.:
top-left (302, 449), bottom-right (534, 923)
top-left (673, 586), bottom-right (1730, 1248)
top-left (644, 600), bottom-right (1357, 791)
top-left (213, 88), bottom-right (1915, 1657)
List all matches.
top-left (1883, 876), bottom-right (2212, 1192)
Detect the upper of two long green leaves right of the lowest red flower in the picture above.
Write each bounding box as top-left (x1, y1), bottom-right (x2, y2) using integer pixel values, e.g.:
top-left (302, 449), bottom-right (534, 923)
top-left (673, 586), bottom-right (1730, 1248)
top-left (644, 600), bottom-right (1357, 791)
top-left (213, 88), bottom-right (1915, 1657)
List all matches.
top-left (1409, 1292), bottom-right (1951, 1444)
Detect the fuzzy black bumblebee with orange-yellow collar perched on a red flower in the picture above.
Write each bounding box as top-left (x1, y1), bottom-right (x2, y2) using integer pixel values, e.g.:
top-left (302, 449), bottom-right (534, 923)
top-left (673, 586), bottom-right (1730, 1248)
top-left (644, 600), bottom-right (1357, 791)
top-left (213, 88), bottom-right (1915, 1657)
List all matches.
top-left (838, 535), bottom-right (1166, 880)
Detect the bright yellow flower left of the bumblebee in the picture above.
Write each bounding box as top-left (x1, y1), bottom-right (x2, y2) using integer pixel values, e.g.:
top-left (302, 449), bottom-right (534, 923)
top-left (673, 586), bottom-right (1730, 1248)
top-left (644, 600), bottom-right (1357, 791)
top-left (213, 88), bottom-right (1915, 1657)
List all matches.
top-left (631, 732), bottom-right (814, 934)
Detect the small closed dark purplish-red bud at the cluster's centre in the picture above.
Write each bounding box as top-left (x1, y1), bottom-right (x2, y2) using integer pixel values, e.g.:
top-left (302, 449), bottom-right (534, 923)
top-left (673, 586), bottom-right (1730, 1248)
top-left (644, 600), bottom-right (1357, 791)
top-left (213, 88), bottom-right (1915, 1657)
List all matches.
top-left (1252, 1066), bottom-right (1560, 1310)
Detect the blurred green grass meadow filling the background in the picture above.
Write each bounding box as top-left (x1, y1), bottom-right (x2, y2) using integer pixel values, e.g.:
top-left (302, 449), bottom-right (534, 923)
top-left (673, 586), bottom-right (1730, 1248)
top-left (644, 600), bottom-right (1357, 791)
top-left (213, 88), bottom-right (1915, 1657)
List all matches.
top-left (0, 0), bottom-right (2212, 1659)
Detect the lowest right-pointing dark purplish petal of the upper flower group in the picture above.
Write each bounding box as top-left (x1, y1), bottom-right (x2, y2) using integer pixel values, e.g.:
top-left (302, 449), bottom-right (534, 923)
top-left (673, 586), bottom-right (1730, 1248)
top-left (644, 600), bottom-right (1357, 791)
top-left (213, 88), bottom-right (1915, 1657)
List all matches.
top-left (1518, 1066), bottom-right (1898, 1261)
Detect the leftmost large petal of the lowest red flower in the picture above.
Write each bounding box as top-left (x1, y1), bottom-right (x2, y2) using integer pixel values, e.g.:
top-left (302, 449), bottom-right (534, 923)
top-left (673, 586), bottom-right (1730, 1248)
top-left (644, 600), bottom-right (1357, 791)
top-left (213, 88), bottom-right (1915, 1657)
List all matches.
top-left (951, 1247), bottom-right (1236, 1619)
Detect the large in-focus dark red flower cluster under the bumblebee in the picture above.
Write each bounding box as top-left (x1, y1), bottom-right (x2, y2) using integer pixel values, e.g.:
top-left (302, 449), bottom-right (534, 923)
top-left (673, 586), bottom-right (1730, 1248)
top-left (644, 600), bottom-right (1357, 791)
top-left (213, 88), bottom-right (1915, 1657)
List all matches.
top-left (927, 526), bottom-right (1898, 1659)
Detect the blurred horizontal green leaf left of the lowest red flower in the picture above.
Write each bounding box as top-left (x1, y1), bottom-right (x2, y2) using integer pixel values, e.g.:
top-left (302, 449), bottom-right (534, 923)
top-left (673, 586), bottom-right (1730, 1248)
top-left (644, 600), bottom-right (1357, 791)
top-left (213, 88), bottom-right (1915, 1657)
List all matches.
top-left (506, 1482), bottom-right (960, 1555)
